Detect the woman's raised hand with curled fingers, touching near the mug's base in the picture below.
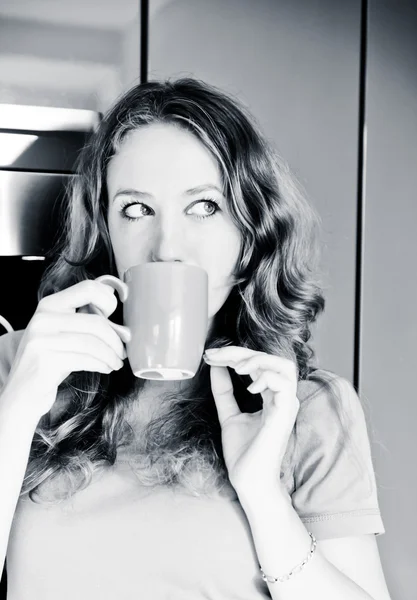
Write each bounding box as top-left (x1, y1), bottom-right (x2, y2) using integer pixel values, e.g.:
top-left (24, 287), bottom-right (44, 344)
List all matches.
top-left (204, 346), bottom-right (300, 497)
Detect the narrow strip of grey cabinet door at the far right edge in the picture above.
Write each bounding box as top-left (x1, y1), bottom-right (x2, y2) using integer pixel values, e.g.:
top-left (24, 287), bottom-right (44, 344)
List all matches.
top-left (360, 0), bottom-right (417, 600)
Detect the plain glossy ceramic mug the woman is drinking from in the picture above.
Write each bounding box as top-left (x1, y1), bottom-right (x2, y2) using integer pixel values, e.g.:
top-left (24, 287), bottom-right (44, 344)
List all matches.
top-left (85, 262), bottom-right (208, 379)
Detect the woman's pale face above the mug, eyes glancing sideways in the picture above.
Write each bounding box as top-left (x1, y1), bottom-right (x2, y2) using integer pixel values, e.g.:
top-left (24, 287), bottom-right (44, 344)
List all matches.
top-left (107, 124), bottom-right (241, 323)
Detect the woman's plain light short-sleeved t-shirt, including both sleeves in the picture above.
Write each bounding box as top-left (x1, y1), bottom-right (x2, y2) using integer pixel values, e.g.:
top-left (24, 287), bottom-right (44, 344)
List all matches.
top-left (0, 330), bottom-right (385, 600)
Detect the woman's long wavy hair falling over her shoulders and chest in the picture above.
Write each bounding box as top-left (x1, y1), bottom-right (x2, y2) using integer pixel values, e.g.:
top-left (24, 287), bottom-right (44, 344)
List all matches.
top-left (21, 78), bottom-right (334, 502)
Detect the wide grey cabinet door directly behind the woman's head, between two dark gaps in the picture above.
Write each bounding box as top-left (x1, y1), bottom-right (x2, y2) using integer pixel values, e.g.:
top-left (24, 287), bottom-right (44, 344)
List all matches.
top-left (149, 0), bottom-right (360, 379)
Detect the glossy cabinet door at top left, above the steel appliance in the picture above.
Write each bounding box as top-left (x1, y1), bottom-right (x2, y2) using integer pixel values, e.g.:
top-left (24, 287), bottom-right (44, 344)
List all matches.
top-left (0, 0), bottom-right (140, 112)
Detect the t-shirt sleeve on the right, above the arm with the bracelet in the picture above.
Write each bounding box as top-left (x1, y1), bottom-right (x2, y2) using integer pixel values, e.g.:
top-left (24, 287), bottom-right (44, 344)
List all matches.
top-left (291, 372), bottom-right (385, 539)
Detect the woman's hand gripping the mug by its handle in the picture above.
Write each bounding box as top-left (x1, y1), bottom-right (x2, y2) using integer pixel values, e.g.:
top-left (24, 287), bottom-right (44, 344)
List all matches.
top-left (2, 280), bottom-right (130, 421)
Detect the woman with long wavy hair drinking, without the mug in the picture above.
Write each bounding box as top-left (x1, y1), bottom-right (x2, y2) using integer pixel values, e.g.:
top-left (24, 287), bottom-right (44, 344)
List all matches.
top-left (0, 79), bottom-right (389, 600)
